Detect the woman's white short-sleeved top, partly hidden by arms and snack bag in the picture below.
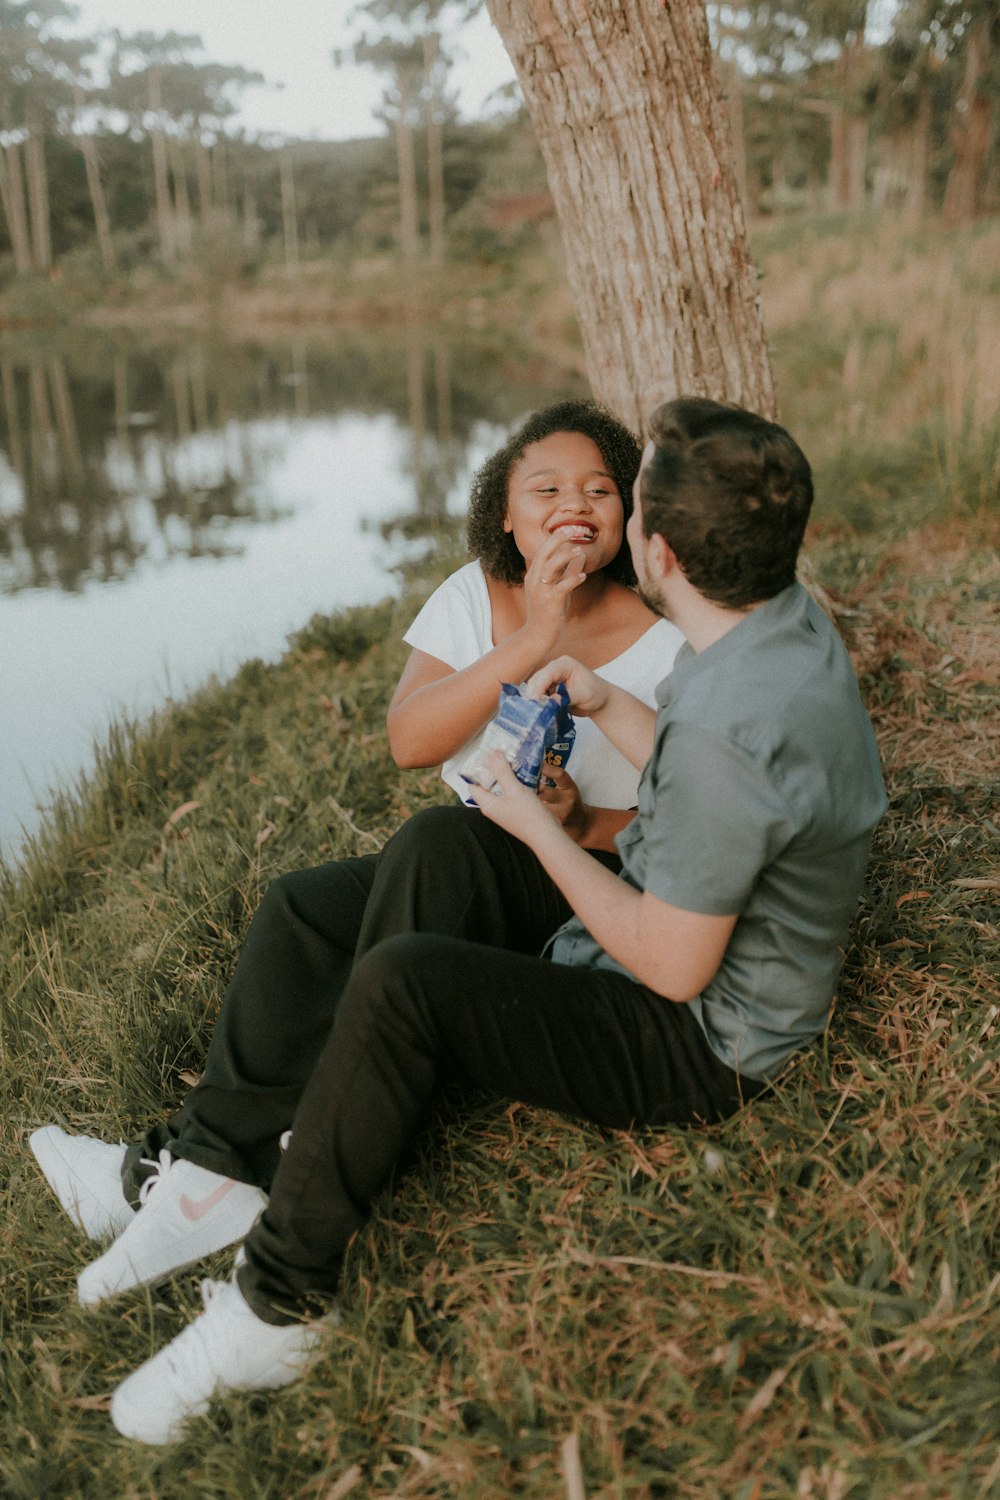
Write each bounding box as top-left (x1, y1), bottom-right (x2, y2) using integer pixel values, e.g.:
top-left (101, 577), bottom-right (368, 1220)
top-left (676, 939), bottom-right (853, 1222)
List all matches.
top-left (403, 563), bottom-right (684, 807)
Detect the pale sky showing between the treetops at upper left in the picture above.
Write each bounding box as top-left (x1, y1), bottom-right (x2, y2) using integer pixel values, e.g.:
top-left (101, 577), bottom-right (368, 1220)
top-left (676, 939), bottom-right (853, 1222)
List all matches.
top-left (62, 0), bottom-right (514, 140)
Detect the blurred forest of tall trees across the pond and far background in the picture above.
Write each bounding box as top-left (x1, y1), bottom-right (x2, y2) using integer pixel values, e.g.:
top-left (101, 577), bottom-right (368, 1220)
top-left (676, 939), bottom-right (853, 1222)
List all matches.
top-left (0, 0), bottom-right (1000, 298)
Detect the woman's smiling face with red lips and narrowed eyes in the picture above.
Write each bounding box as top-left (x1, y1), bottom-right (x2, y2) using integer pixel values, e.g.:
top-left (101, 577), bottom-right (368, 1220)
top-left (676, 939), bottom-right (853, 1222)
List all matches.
top-left (504, 432), bottom-right (624, 573)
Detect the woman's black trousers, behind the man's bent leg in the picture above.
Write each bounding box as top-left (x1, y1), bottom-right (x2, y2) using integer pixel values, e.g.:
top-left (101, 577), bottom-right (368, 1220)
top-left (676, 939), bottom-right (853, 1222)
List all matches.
top-left (123, 806), bottom-right (618, 1205)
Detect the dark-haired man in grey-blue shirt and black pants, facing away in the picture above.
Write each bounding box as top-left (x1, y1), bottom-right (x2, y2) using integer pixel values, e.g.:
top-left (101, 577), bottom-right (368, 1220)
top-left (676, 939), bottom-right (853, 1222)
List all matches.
top-left (111, 399), bottom-right (886, 1443)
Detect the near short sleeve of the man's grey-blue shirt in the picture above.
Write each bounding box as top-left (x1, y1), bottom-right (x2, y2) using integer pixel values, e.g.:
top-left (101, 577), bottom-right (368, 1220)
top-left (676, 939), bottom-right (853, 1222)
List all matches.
top-left (643, 726), bottom-right (795, 917)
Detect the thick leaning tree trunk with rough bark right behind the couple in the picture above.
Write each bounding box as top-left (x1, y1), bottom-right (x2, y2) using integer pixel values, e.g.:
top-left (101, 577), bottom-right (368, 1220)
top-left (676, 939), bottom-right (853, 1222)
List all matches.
top-left (487, 0), bottom-right (775, 429)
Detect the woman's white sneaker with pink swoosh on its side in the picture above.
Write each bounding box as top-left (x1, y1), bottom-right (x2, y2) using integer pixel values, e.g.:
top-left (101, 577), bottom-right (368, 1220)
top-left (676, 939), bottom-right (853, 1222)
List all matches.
top-left (76, 1151), bottom-right (267, 1307)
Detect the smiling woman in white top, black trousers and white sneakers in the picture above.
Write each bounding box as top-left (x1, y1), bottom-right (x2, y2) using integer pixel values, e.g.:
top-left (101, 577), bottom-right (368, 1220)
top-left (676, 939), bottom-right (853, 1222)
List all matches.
top-left (31, 402), bottom-right (681, 1305)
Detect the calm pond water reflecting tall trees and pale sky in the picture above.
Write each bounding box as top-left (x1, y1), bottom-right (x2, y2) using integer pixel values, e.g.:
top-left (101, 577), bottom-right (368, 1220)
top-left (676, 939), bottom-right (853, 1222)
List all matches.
top-left (0, 333), bottom-right (580, 858)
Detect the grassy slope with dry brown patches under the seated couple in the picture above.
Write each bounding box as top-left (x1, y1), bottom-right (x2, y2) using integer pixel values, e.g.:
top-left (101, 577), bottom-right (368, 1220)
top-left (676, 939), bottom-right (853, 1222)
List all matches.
top-left (0, 219), bottom-right (1000, 1500)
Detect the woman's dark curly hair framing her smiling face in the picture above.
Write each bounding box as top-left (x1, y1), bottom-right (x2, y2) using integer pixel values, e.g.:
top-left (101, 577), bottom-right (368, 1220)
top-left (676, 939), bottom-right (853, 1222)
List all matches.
top-left (466, 401), bottom-right (642, 584)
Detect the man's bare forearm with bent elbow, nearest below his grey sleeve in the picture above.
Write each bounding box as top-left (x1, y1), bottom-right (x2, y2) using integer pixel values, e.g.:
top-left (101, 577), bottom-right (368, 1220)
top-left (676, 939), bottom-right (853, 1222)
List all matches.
top-left (469, 752), bottom-right (736, 1001)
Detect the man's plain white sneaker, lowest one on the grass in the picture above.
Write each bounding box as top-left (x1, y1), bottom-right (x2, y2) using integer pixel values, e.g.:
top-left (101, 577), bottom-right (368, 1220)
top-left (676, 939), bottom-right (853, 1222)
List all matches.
top-left (111, 1281), bottom-right (330, 1443)
